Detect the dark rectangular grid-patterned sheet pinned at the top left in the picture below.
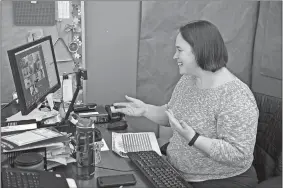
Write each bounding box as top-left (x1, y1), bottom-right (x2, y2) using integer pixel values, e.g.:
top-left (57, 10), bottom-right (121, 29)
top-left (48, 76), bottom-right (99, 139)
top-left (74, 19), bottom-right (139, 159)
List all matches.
top-left (13, 1), bottom-right (56, 26)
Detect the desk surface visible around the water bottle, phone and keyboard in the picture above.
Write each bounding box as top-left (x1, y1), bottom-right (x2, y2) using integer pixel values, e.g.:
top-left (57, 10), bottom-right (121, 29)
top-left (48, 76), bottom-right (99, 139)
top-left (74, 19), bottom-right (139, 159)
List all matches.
top-left (1, 105), bottom-right (152, 188)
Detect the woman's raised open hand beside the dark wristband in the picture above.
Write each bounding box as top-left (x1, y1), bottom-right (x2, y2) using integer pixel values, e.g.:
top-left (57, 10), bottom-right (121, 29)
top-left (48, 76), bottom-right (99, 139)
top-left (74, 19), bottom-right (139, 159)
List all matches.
top-left (165, 109), bottom-right (196, 142)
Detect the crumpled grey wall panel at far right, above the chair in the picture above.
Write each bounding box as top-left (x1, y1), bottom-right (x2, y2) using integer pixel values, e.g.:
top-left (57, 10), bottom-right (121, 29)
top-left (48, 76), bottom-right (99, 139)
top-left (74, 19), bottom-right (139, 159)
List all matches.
top-left (252, 1), bottom-right (282, 98)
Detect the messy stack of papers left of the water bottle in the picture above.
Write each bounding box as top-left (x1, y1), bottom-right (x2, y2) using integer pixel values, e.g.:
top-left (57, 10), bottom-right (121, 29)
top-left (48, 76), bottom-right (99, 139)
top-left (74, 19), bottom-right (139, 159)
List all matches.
top-left (1, 128), bottom-right (75, 169)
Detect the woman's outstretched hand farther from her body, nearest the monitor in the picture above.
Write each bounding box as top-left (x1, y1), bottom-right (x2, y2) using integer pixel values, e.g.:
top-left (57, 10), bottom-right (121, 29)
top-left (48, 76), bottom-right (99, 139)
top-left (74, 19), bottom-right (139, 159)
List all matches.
top-left (111, 95), bottom-right (147, 116)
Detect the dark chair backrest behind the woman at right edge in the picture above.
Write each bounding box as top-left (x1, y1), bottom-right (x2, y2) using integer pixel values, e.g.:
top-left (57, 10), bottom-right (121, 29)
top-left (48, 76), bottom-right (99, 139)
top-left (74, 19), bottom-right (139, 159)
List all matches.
top-left (253, 93), bottom-right (282, 182)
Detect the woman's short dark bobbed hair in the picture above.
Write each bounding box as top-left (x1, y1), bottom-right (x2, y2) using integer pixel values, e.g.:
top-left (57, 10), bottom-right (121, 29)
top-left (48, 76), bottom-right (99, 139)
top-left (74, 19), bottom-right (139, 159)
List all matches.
top-left (180, 20), bottom-right (228, 72)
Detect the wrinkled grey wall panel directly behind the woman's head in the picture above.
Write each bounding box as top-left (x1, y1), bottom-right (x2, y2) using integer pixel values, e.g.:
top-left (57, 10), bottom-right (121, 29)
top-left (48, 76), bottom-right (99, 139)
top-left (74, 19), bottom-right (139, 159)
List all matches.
top-left (137, 0), bottom-right (258, 136)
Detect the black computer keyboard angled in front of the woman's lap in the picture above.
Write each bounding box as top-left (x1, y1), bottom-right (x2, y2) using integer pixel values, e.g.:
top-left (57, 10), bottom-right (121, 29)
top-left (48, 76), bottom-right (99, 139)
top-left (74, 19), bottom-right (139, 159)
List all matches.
top-left (127, 151), bottom-right (193, 188)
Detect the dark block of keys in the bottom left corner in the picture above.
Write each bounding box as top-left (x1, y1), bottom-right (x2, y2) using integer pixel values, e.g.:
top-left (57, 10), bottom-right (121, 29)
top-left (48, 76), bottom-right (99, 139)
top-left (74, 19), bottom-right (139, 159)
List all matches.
top-left (1, 168), bottom-right (40, 188)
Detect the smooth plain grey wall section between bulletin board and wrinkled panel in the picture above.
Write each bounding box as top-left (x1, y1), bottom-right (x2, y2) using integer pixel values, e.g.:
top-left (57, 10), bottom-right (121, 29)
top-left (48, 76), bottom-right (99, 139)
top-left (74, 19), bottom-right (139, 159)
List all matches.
top-left (85, 1), bottom-right (140, 104)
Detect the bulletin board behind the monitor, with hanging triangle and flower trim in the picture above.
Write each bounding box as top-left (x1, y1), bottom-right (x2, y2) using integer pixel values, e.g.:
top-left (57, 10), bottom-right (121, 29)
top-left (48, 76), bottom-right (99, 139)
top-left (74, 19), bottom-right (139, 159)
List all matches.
top-left (1, 0), bottom-right (85, 103)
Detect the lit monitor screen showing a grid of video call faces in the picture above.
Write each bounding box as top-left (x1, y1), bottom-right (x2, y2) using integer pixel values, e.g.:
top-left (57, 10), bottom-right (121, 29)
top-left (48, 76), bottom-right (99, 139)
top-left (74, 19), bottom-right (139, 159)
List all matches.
top-left (15, 41), bottom-right (57, 107)
